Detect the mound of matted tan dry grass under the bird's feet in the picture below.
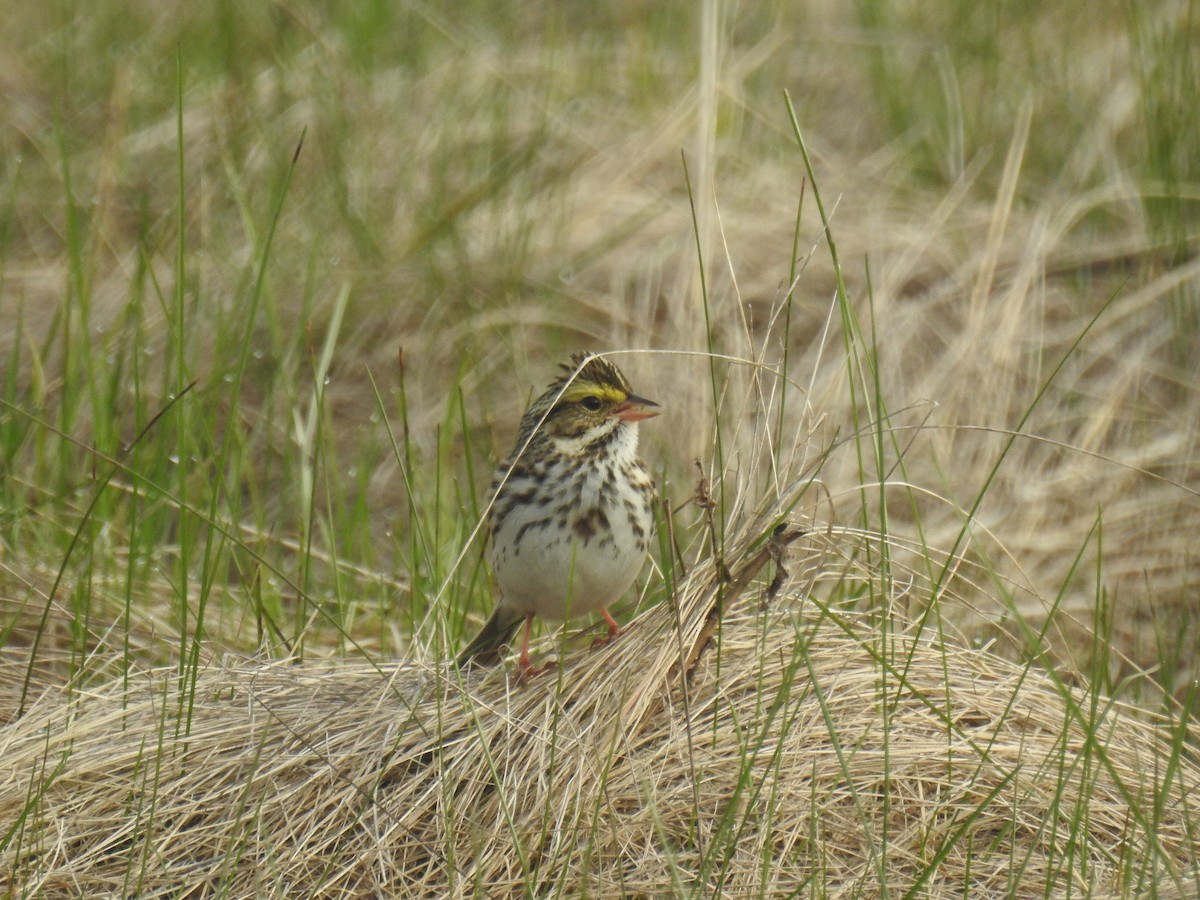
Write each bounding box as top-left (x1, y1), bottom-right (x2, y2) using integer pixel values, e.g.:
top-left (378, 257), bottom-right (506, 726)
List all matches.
top-left (0, 525), bottom-right (1200, 896)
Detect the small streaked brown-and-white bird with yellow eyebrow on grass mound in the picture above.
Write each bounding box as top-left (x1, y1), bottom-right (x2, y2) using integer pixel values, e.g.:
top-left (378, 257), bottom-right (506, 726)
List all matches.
top-left (457, 353), bottom-right (660, 679)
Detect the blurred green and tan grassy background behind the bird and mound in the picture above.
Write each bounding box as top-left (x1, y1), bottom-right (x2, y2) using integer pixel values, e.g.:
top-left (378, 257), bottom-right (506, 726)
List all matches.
top-left (0, 0), bottom-right (1200, 703)
